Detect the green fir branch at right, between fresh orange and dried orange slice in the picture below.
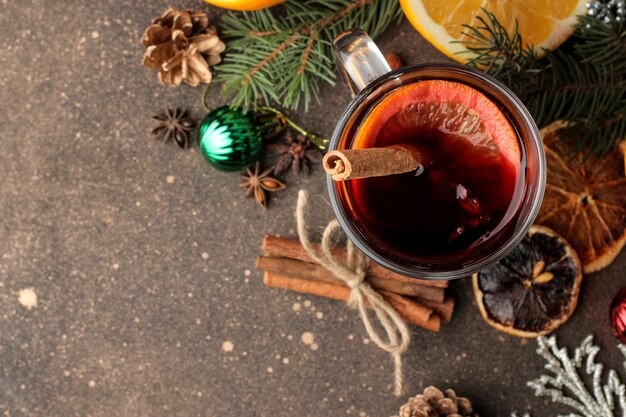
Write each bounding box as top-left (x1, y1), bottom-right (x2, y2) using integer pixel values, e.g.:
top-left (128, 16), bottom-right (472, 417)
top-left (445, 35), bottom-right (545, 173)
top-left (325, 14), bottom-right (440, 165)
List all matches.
top-left (462, 9), bottom-right (626, 156)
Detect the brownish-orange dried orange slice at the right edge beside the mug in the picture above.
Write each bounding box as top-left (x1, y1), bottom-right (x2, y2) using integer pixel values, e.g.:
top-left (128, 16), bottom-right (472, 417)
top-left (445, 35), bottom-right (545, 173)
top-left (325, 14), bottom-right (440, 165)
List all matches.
top-left (536, 122), bottom-right (626, 273)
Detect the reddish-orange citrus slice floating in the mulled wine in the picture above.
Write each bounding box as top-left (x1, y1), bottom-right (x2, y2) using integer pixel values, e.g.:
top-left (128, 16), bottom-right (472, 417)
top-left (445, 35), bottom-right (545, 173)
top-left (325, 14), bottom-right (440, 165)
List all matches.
top-left (354, 80), bottom-right (521, 169)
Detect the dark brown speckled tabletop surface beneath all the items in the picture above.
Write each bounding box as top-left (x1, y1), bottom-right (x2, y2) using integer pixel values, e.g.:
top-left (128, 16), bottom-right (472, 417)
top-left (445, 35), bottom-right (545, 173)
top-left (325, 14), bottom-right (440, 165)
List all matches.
top-left (0, 0), bottom-right (626, 417)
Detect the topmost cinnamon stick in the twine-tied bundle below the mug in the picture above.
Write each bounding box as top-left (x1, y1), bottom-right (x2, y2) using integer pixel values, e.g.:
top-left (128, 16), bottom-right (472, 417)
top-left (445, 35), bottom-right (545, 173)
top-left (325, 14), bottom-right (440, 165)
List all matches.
top-left (262, 235), bottom-right (448, 290)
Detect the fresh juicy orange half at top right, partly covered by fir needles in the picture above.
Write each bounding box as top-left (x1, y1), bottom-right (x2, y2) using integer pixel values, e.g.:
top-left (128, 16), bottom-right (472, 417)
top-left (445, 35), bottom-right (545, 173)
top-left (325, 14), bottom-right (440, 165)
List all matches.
top-left (400, 0), bottom-right (587, 62)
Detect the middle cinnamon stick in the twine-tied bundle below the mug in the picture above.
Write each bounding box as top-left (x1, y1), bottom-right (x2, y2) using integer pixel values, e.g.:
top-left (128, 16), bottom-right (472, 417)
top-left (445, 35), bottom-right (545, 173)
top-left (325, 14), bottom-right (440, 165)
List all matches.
top-left (256, 256), bottom-right (445, 303)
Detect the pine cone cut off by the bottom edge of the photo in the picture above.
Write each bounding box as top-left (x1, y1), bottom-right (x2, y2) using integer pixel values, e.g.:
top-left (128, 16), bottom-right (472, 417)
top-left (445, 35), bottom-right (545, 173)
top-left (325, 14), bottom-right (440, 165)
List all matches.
top-left (400, 387), bottom-right (478, 417)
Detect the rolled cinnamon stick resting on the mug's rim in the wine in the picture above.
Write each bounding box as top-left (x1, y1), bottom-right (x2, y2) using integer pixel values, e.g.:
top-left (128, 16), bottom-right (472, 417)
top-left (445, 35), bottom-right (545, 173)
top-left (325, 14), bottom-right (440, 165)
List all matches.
top-left (322, 145), bottom-right (428, 181)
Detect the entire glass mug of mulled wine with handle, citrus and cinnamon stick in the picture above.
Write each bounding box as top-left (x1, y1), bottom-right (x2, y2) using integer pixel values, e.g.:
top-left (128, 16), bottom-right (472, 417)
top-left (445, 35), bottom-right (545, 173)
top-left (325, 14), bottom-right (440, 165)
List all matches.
top-left (322, 29), bottom-right (546, 279)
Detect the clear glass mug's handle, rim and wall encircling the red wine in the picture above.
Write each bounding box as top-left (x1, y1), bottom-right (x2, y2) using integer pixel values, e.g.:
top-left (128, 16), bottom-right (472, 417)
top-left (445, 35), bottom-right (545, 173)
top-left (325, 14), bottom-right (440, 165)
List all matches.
top-left (327, 29), bottom-right (546, 279)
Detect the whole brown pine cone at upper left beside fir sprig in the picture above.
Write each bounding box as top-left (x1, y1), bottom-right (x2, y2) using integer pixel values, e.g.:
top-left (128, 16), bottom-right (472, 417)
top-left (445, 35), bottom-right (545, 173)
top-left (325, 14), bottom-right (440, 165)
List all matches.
top-left (141, 7), bottom-right (225, 87)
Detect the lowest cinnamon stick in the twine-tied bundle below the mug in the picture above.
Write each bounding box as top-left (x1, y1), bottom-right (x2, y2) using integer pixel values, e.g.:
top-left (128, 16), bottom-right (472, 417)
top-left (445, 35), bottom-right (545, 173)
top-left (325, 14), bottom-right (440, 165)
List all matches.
top-left (263, 272), bottom-right (441, 332)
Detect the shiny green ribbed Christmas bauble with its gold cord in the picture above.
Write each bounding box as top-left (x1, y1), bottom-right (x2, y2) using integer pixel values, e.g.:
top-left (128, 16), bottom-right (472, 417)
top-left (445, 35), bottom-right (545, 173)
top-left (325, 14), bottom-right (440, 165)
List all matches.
top-left (198, 106), bottom-right (328, 172)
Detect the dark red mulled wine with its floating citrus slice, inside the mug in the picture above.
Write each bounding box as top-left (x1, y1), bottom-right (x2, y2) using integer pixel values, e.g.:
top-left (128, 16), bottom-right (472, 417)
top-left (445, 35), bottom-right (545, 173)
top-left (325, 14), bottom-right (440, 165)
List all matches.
top-left (342, 80), bottom-right (524, 264)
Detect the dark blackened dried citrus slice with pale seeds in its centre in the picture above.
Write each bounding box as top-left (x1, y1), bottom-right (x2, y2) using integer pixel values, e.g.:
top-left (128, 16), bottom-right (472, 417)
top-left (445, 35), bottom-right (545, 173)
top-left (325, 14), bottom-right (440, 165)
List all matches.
top-left (472, 226), bottom-right (582, 337)
